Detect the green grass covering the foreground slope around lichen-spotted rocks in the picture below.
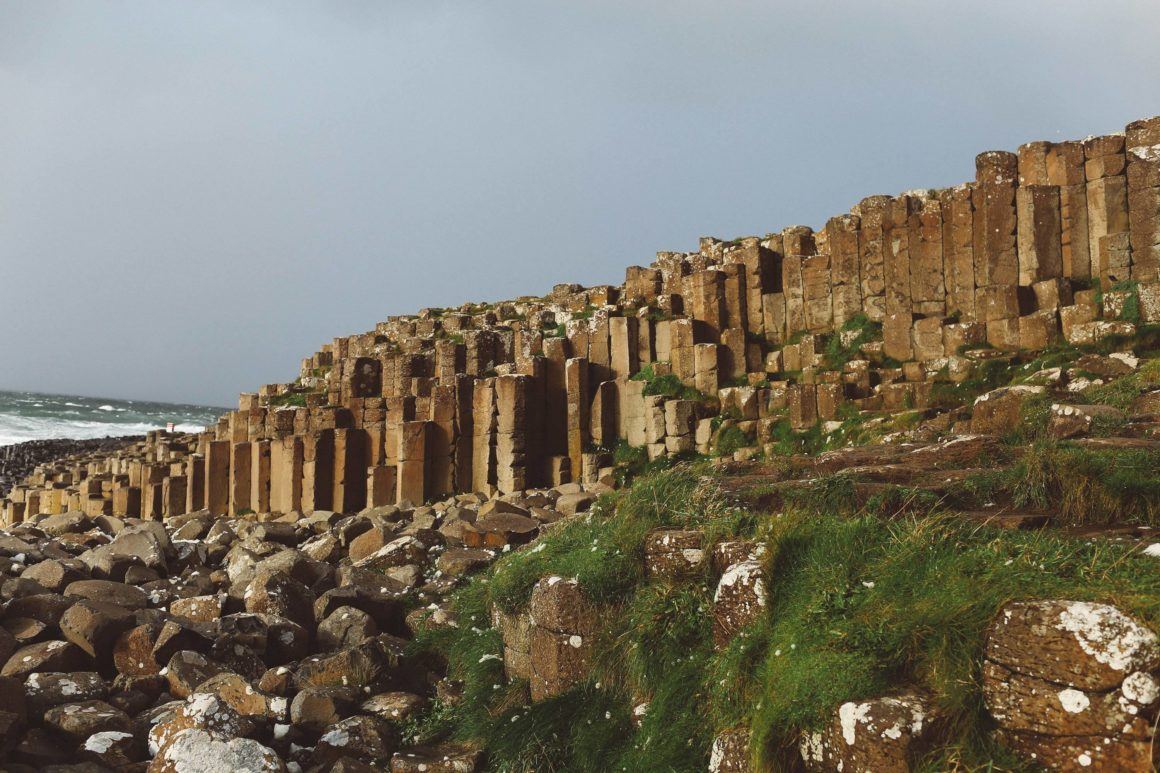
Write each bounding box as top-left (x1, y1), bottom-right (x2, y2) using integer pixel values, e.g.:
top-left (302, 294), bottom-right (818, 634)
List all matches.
top-left (406, 464), bottom-right (1160, 771)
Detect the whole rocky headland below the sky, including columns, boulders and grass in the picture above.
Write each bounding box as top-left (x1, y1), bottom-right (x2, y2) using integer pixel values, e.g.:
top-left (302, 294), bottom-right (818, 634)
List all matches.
top-left (0, 113), bottom-right (1160, 772)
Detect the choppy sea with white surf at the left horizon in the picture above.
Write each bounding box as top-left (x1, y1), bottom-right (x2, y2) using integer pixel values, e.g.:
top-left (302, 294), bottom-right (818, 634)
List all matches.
top-left (0, 391), bottom-right (226, 446)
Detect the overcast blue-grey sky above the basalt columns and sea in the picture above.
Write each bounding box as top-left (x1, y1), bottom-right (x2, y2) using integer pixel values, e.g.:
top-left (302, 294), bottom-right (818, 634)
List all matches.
top-left (0, 0), bottom-right (1160, 405)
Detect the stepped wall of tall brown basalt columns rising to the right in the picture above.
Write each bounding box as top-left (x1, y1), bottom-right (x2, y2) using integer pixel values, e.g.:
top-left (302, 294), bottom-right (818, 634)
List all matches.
top-left (5, 118), bottom-right (1160, 522)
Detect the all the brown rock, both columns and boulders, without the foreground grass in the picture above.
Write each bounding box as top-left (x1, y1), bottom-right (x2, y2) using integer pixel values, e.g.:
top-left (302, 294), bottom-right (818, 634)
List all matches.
top-left (0, 111), bottom-right (1160, 773)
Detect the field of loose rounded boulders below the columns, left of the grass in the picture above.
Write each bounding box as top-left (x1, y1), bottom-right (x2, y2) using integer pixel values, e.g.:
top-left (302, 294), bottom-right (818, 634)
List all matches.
top-left (0, 484), bottom-right (607, 773)
